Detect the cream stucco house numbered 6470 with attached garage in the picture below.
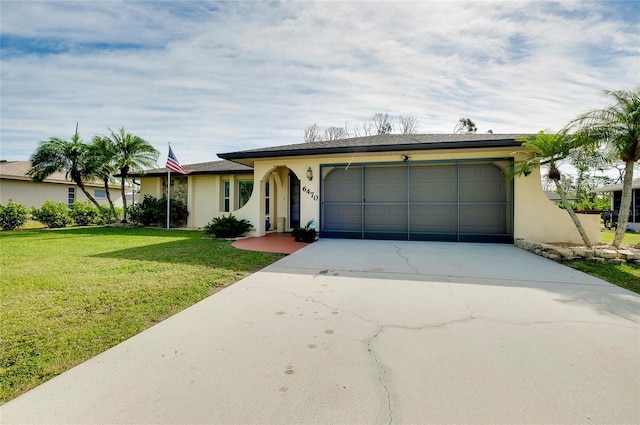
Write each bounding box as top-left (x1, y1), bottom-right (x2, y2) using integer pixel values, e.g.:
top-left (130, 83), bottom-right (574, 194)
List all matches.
top-left (132, 134), bottom-right (600, 243)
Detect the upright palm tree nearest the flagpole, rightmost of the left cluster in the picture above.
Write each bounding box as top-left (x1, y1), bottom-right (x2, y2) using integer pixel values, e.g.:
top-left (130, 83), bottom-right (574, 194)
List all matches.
top-left (109, 128), bottom-right (160, 223)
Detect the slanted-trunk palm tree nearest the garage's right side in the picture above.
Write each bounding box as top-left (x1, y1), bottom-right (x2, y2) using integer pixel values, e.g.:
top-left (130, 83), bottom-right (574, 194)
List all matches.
top-left (509, 131), bottom-right (591, 247)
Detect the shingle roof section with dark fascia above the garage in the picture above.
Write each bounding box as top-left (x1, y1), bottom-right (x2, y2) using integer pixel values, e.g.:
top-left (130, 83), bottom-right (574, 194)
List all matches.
top-left (218, 134), bottom-right (523, 159)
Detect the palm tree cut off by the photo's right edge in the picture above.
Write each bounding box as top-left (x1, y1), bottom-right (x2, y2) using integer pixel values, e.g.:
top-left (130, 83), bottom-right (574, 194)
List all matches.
top-left (570, 87), bottom-right (640, 247)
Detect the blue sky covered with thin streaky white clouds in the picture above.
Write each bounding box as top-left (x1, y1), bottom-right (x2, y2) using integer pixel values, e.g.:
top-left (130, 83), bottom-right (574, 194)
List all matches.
top-left (0, 0), bottom-right (640, 166)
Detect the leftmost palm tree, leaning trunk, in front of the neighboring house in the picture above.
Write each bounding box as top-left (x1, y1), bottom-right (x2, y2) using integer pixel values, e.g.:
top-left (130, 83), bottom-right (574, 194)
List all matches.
top-left (27, 125), bottom-right (100, 209)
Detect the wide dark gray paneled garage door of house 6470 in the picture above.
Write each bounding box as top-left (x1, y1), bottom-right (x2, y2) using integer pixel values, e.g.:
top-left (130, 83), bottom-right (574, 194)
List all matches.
top-left (320, 160), bottom-right (513, 243)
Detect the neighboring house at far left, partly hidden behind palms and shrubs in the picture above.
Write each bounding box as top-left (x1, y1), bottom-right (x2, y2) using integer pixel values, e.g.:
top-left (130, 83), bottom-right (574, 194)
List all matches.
top-left (0, 161), bottom-right (122, 208)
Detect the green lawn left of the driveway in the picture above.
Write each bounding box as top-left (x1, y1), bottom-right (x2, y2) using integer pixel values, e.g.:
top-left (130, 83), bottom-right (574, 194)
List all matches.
top-left (0, 227), bottom-right (283, 403)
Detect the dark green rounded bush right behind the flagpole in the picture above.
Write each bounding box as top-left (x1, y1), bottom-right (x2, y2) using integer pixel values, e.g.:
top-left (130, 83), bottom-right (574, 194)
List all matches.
top-left (128, 195), bottom-right (189, 227)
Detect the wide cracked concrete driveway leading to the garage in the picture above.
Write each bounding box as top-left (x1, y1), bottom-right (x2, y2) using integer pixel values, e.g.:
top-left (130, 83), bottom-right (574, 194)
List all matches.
top-left (1, 240), bottom-right (640, 424)
